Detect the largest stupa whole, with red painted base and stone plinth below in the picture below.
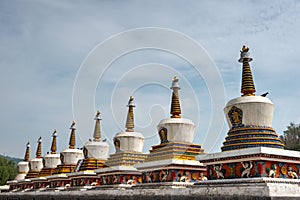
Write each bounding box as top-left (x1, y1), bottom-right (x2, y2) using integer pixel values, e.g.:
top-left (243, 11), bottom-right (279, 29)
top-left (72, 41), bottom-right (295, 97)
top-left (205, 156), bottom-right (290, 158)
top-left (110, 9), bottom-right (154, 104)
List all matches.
top-left (198, 46), bottom-right (300, 198)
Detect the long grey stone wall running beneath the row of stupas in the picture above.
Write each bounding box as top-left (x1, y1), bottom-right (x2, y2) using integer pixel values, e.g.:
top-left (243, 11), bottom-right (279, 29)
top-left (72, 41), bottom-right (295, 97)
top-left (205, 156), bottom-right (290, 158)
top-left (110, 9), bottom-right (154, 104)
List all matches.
top-left (0, 180), bottom-right (300, 200)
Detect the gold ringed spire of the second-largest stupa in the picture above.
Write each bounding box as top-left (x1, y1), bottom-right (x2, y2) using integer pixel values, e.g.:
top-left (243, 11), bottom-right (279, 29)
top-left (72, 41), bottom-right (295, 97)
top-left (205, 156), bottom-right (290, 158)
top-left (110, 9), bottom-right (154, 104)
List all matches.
top-left (170, 76), bottom-right (181, 118)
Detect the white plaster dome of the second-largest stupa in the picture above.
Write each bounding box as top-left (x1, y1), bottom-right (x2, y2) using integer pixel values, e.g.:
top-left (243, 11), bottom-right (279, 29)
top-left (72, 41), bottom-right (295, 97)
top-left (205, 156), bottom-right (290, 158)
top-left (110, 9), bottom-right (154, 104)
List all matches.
top-left (157, 118), bottom-right (195, 143)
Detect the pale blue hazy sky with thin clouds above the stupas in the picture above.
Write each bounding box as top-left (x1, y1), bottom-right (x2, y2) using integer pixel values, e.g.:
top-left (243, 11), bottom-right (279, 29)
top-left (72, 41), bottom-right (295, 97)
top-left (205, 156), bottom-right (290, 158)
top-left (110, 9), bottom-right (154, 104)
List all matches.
top-left (0, 0), bottom-right (300, 157)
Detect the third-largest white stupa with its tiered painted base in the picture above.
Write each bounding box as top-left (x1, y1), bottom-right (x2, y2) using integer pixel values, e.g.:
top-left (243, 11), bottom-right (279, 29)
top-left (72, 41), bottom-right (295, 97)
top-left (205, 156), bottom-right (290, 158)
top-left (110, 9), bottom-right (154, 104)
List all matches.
top-left (95, 96), bottom-right (147, 185)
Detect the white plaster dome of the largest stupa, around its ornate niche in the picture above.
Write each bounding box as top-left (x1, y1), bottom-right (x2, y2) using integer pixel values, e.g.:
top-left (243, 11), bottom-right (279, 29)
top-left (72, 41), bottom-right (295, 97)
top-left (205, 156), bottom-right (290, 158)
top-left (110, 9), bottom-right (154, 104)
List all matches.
top-left (224, 96), bottom-right (274, 128)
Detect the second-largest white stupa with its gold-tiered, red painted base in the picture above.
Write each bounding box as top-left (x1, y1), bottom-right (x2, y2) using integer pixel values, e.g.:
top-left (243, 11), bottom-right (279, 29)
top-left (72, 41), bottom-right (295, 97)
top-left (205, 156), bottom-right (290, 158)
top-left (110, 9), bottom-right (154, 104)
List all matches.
top-left (134, 77), bottom-right (206, 183)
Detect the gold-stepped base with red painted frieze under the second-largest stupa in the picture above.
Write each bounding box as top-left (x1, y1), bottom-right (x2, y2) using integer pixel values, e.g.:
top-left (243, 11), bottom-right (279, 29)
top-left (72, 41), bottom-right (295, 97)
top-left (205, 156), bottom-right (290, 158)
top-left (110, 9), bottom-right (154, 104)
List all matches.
top-left (135, 142), bottom-right (206, 183)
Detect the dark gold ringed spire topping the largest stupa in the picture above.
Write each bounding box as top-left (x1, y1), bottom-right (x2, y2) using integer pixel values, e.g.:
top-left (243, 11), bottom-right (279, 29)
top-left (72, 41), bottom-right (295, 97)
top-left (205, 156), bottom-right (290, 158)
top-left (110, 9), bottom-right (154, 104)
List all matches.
top-left (239, 45), bottom-right (256, 96)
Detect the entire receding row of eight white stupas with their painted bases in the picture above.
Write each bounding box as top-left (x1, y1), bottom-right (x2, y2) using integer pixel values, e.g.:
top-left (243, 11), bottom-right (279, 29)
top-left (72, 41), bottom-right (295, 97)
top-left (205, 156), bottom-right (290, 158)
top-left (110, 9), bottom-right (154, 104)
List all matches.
top-left (9, 46), bottom-right (300, 197)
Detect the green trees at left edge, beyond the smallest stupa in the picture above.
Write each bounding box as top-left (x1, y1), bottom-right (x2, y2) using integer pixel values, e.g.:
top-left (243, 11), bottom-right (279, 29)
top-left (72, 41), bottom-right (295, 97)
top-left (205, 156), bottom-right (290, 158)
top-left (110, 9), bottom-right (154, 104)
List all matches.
top-left (0, 157), bottom-right (18, 185)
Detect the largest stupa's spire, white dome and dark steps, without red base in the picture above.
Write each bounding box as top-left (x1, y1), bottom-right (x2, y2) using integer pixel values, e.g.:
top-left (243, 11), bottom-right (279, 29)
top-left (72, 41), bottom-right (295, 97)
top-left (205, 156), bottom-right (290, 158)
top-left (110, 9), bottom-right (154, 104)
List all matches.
top-left (221, 46), bottom-right (284, 151)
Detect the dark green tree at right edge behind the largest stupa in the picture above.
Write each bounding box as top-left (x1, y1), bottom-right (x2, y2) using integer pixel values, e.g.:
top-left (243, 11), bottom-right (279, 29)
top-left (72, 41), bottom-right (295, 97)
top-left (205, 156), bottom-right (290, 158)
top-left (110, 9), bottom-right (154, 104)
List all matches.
top-left (280, 122), bottom-right (300, 151)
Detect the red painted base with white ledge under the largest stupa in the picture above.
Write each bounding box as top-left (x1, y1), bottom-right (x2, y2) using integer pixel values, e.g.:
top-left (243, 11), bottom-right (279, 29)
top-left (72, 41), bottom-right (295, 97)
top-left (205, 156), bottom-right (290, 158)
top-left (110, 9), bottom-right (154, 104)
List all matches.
top-left (197, 147), bottom-right (300, 180)
